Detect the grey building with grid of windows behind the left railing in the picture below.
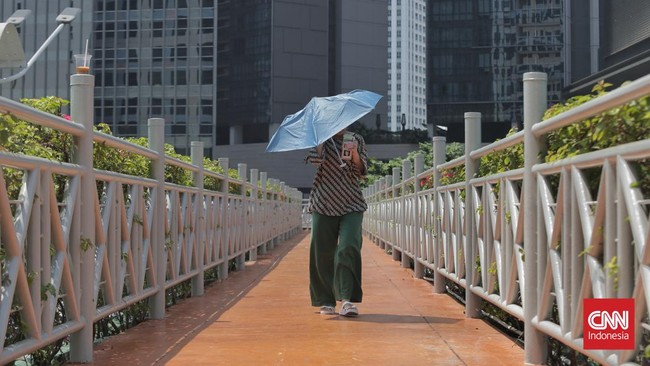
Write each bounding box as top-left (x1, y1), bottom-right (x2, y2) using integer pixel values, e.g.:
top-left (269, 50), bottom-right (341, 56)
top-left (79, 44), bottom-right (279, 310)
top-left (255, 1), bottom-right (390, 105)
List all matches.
top-left (91, 0), bottom-right (217, 156)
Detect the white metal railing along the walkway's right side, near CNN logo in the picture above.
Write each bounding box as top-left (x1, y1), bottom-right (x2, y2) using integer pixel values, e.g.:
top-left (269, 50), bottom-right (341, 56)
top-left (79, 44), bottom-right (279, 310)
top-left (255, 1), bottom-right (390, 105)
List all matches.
top-left (364, 73), bottom-right (650, 365)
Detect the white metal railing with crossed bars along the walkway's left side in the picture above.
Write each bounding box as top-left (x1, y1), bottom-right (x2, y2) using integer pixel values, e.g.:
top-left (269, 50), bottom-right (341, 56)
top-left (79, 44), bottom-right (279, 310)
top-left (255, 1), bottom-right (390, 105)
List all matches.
top-left (0, 75), bottom-right (302, 364)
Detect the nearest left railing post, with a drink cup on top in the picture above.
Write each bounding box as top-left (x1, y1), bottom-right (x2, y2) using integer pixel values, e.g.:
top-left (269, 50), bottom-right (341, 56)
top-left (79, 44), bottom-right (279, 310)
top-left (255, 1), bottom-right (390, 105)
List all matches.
top-left (70, 74), bottom-right (99, 363)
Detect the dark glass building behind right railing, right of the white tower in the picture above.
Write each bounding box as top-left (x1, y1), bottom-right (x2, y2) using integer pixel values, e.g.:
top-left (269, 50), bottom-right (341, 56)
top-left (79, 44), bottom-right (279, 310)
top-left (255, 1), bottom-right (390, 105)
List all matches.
top-left (427, 0), bottom-right (564, 141)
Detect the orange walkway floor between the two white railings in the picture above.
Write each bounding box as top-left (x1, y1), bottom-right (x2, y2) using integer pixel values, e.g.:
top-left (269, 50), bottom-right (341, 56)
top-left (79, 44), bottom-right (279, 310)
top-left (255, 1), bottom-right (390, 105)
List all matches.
top-left (81, 231), bottom-right (524, 366)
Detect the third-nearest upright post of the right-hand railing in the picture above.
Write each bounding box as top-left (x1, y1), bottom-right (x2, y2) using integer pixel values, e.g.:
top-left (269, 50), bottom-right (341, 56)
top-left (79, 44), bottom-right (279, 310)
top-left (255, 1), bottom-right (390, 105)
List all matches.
top-left (433, 136), bottom-right (447, 294)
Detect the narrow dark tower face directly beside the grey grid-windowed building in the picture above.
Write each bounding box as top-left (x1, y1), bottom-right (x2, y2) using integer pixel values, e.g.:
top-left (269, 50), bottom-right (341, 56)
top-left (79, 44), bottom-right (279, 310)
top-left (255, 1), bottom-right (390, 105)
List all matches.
top-left (216, 0), bottom-right (272, 145)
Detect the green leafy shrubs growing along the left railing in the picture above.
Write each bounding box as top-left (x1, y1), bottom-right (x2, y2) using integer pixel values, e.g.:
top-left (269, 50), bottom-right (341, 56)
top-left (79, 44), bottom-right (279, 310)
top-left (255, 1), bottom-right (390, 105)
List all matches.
top-left (0, 97), bottom-right (258, 365)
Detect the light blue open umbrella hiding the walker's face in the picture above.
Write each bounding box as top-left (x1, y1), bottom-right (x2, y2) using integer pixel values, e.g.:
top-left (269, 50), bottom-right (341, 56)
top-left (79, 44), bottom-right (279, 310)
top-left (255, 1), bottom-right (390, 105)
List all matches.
top-left (266, 89), bottom-right (381, 152)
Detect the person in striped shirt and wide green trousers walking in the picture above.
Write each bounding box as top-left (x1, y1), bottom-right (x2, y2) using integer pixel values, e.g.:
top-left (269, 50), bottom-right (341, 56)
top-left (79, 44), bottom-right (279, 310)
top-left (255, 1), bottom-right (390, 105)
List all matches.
top-left (306, 130), bottom-right (368, 316)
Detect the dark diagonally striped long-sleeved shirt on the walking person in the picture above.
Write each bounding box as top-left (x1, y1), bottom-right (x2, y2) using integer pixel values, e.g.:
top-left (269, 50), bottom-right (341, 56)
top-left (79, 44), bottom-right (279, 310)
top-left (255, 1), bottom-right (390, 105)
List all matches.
top-left (306, 133), bottom-right (368, 216)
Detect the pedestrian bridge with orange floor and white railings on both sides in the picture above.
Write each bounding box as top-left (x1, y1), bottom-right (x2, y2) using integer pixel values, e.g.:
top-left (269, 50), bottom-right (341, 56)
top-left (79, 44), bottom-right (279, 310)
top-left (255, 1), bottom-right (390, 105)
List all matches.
top-left (0, 72), bottom-right (650, 365)
